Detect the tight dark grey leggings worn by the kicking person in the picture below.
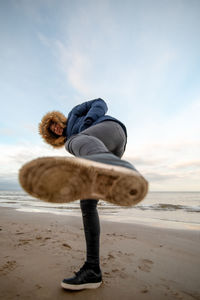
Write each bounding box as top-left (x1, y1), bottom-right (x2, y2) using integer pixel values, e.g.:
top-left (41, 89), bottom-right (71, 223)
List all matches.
top-left (65, 121), bottom-right (126, 265)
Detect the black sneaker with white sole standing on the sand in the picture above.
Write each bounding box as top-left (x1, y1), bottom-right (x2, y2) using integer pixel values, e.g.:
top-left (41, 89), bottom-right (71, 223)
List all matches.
top-left (61, 262), bottom-right (102, 290)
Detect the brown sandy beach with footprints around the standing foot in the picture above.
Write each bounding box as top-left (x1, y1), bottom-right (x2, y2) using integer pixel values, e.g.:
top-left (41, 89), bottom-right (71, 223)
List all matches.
top-left (0, 208), bottom-right (200, 300)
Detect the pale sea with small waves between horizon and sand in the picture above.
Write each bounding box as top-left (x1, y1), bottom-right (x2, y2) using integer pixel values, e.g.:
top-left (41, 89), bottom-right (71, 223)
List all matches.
top-left (0, 190), bottom-right (200, 230)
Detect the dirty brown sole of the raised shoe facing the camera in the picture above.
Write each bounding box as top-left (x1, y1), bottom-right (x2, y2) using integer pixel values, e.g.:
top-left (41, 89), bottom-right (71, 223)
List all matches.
top-left (19, 157), bottom-right (148, 206)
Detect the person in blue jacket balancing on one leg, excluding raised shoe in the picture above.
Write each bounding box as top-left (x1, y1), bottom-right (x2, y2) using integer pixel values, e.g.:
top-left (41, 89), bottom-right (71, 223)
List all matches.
top-left (39, 98), bottom-right (142, 290)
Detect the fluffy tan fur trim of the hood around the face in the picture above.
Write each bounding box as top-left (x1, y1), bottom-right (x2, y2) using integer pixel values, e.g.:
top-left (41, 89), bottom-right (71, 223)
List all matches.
top-left (39, 111), bottom-right (67, 148)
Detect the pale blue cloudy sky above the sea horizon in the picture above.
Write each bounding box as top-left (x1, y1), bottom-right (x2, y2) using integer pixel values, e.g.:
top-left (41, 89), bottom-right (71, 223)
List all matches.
top-left (0, 0), bottom-right (200, 191)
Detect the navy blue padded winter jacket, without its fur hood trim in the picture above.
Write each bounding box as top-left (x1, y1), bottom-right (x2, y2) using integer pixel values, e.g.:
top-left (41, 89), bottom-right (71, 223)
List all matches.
top-left (66, 98), bottom-right (127, 139)
